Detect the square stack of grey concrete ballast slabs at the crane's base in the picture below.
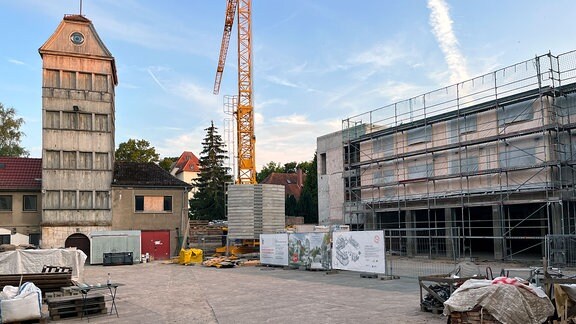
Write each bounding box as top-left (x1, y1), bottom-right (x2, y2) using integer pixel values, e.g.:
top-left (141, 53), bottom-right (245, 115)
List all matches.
top-left (228, 184), bottom-right (285, 239)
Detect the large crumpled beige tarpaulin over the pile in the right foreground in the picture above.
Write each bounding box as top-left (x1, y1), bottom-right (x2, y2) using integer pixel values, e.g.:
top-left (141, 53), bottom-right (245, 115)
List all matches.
top-left (444, 278), bottom-right (554, 324)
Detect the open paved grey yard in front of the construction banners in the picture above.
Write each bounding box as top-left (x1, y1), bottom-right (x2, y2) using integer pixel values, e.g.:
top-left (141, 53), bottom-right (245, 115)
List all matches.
top-left (50, 262), bottom-right (446, 324)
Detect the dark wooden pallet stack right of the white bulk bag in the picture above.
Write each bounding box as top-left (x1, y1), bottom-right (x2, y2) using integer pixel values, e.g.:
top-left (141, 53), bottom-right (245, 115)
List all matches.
top-left (46, 294), bottom-right (108, 320)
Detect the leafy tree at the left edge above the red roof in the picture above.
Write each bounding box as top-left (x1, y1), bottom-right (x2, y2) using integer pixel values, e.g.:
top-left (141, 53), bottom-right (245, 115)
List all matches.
top-left (0, 103), bottom-right (29, 157)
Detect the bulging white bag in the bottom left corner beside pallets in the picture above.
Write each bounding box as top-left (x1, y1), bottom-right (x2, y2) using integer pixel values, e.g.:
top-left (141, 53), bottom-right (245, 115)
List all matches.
top-left (0, 282), bottom-right (42, 323)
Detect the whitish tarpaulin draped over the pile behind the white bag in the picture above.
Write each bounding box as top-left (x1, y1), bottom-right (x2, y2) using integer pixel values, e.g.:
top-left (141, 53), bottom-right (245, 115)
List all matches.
top-left (0, 249), bottom-right (86, 282)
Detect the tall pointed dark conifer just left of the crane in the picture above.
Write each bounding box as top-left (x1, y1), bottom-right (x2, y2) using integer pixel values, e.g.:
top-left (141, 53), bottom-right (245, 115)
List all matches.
top-left (190, 122), bottom-right (232, 220)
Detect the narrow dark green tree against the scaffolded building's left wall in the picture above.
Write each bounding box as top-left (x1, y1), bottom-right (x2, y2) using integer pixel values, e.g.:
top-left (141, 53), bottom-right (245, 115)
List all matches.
top-left (298, 153), bottom-right (318, 224)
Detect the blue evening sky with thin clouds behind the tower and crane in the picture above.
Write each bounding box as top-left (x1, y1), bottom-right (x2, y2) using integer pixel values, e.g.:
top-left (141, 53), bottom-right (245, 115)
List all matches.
top-left (0, 0), bottom-right (576, 170)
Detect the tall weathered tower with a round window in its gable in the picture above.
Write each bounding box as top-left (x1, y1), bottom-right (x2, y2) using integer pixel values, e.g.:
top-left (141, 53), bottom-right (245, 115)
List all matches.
top-left (39, 15), bottom-right (117, 247)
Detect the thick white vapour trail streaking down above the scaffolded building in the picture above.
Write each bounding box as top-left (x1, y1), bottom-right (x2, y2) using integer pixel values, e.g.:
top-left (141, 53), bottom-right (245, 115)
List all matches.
top-left (428, 0), bottom-right (470, 83)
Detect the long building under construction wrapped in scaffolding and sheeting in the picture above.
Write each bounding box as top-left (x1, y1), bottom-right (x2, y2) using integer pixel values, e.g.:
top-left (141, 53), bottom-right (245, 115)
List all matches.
top-left (318, 51), bottom-right (576, 259)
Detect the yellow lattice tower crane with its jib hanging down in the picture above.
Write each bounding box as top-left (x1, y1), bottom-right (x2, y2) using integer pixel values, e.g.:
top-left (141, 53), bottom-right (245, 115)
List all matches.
top-left (214, 0), bottom-right (256, 184)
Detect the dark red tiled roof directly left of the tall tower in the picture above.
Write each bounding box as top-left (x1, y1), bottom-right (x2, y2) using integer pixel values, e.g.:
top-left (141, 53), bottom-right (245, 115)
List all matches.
top-left (0, 157), bottom-right (42, 190)
